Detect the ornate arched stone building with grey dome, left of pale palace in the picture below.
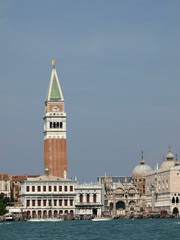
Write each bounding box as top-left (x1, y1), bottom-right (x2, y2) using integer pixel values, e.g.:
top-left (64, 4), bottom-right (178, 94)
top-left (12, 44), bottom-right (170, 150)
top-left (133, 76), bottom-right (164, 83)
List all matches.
top-left (97, 153), bottom-right (152, 216)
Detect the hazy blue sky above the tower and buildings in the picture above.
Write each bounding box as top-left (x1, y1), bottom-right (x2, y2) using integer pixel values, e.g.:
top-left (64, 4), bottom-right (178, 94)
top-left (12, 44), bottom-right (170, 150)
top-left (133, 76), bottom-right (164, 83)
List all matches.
top-left (0, 0), bottom-right (180, 182)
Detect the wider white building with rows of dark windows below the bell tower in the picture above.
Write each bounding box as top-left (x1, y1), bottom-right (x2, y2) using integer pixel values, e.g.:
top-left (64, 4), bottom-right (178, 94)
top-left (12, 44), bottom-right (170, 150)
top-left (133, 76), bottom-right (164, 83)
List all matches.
top-left (21, 170), bottom-right (76, 218)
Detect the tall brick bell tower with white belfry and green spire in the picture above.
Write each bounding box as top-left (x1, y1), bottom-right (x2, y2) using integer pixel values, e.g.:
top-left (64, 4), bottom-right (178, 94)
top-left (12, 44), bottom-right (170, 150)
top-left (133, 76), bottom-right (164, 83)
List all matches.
top-left (43, 61), bottom-right (67, 178)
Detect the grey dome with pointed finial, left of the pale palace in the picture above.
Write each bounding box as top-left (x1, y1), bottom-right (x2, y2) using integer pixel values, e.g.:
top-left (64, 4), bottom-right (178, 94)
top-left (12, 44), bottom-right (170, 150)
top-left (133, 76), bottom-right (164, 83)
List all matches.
top-left (132, 155), bottom-right (152, 179)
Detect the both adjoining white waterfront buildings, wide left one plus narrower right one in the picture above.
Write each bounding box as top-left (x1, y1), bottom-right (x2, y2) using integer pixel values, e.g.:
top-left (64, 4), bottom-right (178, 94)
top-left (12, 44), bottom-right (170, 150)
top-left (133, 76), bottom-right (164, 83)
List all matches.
top-left (21, 169), bottom-right (103, 218)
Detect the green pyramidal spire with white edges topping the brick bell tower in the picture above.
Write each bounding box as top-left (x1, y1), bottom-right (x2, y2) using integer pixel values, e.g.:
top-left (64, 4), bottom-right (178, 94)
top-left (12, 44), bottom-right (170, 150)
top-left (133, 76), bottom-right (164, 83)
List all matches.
top-left (46, 61), bottom-right (64, 101)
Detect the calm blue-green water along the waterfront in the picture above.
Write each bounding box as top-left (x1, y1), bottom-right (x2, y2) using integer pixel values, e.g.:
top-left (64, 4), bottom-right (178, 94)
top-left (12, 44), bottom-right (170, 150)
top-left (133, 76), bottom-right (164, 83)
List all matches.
top-left (0, 219), bottom-right (180, 240)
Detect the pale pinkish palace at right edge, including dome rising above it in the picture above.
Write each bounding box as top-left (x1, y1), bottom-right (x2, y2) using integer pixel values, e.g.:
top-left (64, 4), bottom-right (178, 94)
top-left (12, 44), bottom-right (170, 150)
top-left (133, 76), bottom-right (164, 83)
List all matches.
top-left (146, 147), bottom-right (180, 215)
